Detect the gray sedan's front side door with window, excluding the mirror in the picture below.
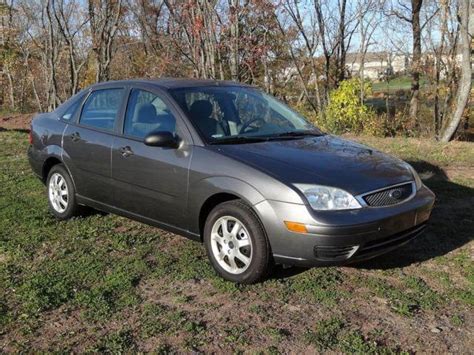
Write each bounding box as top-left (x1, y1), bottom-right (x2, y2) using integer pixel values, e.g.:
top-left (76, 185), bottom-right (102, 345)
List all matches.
top-left (112, 87), bottom-right (192, 226)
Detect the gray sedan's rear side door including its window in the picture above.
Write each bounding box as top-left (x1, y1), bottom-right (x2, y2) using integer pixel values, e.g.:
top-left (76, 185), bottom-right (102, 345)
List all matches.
top-left (63, 87), bottom-right (125, 204)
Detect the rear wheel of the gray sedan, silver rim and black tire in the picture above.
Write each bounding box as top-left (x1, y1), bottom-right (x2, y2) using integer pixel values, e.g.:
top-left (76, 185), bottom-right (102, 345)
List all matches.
top-left (46, 164), bottom-right (80, 220)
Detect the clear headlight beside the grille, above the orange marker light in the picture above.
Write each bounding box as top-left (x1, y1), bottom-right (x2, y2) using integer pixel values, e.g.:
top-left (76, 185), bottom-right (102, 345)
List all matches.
top-left (295, 184), bottom-right (362, 211)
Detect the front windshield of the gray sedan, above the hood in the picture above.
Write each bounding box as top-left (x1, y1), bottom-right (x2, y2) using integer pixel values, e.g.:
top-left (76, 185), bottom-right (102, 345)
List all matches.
top-left (171, 86), bottom-right (321, 144)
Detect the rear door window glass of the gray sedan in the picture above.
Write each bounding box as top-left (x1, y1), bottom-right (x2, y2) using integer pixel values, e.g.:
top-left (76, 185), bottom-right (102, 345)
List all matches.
top-left (79, 89), bottom-right (124, 131)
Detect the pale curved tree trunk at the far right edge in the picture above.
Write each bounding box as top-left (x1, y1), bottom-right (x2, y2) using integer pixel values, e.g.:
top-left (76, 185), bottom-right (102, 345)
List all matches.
top-left (441, 0), bottom-right (472, 142)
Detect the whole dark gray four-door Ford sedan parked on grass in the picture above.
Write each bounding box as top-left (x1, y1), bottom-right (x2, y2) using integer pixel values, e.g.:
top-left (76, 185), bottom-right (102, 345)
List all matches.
top-left (28, 79), bottom-right (434, 283)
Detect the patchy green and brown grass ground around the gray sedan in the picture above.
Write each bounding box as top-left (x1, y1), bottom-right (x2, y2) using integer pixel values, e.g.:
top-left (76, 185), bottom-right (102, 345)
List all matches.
top-left (0, 128), bottom-right (474, 353)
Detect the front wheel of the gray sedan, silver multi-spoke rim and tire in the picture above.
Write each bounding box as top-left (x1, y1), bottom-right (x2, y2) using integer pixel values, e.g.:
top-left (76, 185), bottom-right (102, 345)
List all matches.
top-left (204, 200), bottom-right (272, 284)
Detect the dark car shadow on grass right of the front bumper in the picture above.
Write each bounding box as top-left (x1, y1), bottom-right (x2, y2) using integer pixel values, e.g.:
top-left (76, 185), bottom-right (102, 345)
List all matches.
top-left (352, 161), bottom-right (474, 269)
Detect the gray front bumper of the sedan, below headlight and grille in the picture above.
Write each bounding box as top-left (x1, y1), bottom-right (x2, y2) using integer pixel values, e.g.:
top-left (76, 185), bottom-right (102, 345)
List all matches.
top-left (254, 186), bottom-right (435, 266)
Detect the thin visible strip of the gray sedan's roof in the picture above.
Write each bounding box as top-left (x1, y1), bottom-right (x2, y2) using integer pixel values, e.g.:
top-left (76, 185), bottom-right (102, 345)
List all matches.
top-left (89, 78), bottom-right (250, 89)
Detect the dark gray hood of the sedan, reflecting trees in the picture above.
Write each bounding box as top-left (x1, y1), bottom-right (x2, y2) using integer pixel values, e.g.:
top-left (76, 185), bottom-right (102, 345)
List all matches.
top-left (212, 135), bottom-right (413, 194)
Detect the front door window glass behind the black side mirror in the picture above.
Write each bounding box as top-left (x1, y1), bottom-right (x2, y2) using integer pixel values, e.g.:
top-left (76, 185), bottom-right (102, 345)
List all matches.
top-left (124, 89), bottom-right (176, 138)
